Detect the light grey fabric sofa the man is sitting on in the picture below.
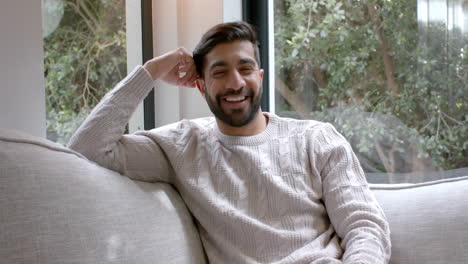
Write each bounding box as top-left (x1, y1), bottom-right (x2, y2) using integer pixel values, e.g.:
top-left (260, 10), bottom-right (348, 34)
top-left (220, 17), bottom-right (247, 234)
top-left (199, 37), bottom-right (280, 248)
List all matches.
top-left (0, 129), bottom-right (468, 264)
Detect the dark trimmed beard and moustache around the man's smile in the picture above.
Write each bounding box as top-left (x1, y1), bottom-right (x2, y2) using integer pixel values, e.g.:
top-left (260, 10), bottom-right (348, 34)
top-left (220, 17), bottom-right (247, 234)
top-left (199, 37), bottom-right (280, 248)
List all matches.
top-left (205, 86), bottom-right (262, 127)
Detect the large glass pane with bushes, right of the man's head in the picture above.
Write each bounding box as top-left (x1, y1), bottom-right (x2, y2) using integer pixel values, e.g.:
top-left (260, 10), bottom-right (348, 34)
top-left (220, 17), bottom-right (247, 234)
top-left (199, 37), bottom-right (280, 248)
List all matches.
top-left (274, 0), bottom-right (468, 183)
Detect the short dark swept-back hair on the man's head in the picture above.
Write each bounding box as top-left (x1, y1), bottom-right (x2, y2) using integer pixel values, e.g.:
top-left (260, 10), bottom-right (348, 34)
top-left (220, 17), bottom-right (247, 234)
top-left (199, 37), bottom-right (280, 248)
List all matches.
top-left (193, 21), bottom-right (260, 77)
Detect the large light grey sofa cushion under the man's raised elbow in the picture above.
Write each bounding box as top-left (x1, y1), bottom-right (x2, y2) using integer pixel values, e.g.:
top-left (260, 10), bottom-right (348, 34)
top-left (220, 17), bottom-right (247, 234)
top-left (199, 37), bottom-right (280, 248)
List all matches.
top-left (0, 130), bottom-right (205, 264)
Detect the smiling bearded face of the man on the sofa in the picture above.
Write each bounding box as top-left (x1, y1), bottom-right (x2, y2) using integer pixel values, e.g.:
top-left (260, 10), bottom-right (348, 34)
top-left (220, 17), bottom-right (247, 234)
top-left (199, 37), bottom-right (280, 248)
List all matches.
top-left (199, 41), bottom-right (263, 127)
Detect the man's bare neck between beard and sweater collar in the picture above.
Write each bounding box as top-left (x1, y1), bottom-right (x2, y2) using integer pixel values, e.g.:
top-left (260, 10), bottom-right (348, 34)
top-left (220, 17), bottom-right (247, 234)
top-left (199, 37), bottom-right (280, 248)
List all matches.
top-left (216, 109), bottom-right (268, 137)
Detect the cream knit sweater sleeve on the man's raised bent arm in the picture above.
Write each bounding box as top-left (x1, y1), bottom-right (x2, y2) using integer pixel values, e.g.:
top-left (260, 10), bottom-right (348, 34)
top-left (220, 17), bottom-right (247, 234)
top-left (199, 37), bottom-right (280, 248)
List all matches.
top-left (68, 66), bottom-right (174, 182)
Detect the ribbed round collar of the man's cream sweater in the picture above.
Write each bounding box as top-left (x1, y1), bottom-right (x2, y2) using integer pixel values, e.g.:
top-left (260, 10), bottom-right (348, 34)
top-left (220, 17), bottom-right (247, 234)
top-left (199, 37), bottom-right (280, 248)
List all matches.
top-left (214, 112), bottom-right (278, 146)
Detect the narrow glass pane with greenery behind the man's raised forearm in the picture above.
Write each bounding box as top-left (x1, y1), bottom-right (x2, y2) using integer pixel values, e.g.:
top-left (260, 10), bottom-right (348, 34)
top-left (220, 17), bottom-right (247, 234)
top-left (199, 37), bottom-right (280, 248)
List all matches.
top-left (42, 0), bottom-right (127, 144)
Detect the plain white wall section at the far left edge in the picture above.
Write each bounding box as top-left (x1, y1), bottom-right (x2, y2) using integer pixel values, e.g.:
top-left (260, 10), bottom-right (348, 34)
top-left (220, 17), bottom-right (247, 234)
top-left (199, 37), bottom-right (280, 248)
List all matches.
top-left (0, 0), bottom-right (46, 137)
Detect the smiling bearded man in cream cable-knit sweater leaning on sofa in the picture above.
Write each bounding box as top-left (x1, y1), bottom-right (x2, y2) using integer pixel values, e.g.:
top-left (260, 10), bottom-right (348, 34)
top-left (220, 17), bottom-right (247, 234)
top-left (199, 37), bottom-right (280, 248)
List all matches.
top-left (70, 22), bottom-right (390, 264)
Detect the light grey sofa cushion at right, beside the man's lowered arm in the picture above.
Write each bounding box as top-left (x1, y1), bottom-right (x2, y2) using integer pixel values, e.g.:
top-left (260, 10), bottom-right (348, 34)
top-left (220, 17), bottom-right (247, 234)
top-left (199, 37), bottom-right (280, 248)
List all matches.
top-left (371, 177), bottom-right (468, 264)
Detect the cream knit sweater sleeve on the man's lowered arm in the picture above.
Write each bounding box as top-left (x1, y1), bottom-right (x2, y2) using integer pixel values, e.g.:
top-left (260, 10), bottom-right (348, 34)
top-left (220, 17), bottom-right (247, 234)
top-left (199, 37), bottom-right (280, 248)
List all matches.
top-left (315, 124), bottom-right (391, 264)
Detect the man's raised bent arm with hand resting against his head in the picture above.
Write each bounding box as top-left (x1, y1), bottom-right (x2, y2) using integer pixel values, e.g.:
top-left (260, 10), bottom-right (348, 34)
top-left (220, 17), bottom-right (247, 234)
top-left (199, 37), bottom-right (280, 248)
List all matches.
top-left (69, 48), bottom-right (197, 181)
